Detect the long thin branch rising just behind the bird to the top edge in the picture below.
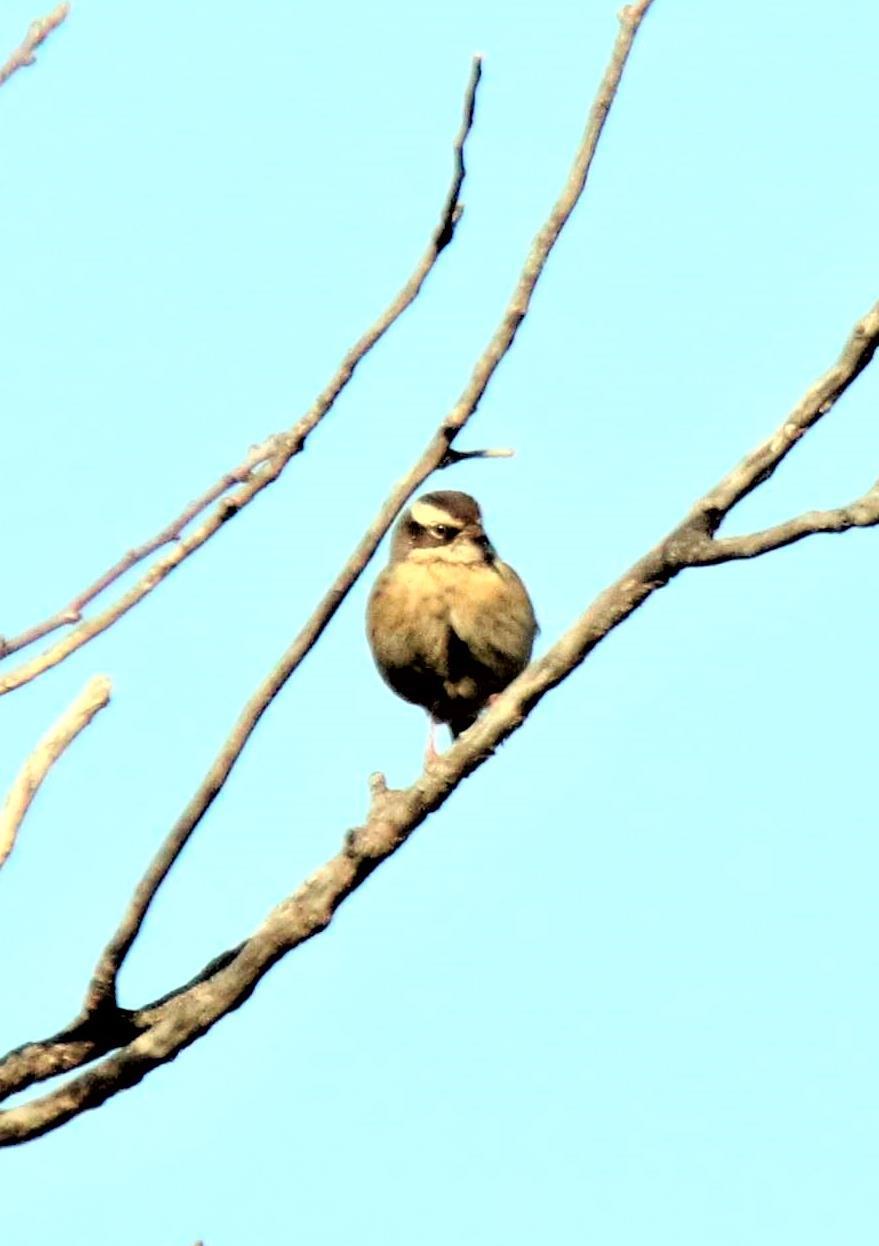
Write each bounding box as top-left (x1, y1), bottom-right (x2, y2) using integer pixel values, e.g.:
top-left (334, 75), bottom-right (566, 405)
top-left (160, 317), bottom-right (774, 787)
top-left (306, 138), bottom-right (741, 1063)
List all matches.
top-left (86, 0), bottom-right (652, 1012)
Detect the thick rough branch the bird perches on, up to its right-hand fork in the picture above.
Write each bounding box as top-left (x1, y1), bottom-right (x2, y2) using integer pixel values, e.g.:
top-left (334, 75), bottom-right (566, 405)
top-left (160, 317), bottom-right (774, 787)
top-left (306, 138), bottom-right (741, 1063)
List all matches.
top-left (0, 533), bottom-right (668, 1145)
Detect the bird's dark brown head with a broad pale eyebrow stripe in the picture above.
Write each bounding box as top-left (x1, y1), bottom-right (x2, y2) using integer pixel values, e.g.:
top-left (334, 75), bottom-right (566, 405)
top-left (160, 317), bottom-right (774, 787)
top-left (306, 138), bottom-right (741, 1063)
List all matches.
top-left (390, 490), bottom-right (495, 563)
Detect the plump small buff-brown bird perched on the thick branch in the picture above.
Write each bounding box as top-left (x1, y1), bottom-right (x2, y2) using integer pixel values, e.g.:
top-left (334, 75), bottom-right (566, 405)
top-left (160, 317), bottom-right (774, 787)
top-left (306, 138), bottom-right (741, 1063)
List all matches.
top-left (367, 491), bottom-right (537, 755)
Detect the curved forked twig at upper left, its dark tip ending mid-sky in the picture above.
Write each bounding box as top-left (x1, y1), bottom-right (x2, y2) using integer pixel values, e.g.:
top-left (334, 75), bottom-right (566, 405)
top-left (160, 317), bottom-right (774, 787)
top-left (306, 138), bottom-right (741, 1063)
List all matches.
top-left (0, 56), bottom-right (483, 695)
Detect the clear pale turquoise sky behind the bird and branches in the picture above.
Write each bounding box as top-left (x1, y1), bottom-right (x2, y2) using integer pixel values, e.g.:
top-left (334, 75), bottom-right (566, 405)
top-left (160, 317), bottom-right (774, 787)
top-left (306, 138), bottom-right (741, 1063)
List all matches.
top-left (0, 0), bottom-right (879, 1246)
